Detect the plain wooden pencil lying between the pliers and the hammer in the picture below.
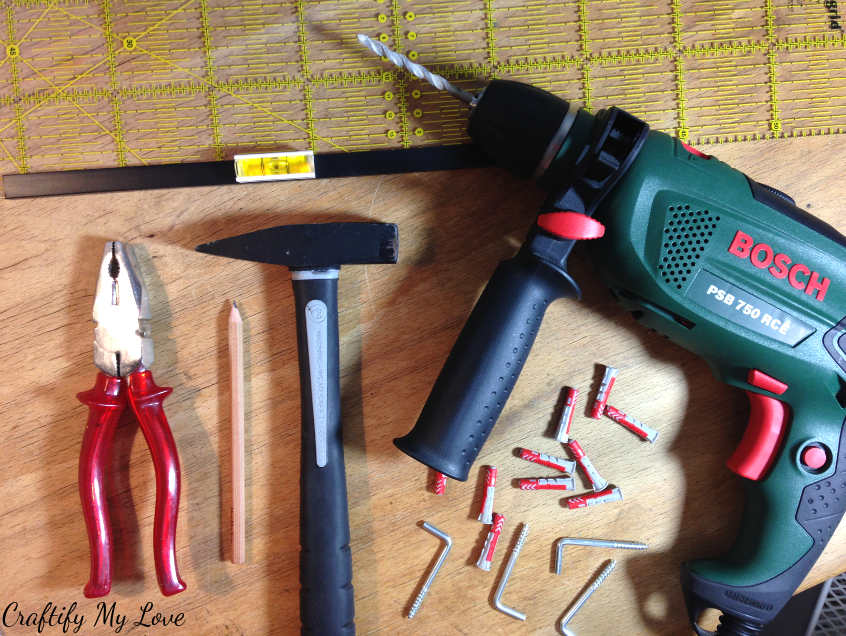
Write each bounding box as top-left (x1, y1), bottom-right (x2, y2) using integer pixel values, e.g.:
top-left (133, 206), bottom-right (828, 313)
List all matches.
top-left (229, 301), bottom-right (247, 563)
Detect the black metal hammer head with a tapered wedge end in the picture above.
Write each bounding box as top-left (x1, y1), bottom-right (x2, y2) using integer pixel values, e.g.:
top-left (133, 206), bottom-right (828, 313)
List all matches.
top-left (196, 223), bottom-right (399, 269)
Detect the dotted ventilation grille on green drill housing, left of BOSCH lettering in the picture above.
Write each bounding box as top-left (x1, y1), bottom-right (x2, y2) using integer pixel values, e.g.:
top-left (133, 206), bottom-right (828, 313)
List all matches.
top-left (658, 205), bottom-right (720, 289)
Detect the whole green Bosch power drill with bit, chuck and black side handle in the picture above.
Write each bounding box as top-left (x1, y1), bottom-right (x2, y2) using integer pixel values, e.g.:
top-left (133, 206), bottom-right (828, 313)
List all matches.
top-left (359, 36), bottom-right (846, 636)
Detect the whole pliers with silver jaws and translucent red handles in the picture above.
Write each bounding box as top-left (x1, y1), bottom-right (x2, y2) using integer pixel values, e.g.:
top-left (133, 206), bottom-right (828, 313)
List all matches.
top-left (77, 241), bottom-right (185, 598)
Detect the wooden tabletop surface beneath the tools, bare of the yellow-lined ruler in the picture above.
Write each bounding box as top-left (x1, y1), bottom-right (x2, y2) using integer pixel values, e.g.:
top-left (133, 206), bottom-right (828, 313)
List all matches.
top-left (0, 136), bottom-right (846, 635)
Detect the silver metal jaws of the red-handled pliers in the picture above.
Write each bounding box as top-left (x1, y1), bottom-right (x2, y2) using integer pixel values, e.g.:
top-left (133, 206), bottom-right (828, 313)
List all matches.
top-left (94, 241), bottom-right (153, 377)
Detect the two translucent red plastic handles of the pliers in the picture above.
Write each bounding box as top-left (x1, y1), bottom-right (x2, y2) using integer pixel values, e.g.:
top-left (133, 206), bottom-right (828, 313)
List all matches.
top-left (77, 370), bottom-right (185, 598)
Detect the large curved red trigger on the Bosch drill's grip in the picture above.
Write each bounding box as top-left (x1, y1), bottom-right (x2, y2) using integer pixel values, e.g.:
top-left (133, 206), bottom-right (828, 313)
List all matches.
top-left (726, 391), bottom-right (787, 481)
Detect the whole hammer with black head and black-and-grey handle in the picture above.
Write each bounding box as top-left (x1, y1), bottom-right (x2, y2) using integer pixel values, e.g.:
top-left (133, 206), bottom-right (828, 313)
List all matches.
top-left (196, 223), bottom-right (399, 636)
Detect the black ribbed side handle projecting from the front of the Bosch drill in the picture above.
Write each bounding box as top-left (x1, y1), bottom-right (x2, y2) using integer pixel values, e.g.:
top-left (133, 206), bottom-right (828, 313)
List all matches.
top-left (394, 249), bottom-right (579, 481)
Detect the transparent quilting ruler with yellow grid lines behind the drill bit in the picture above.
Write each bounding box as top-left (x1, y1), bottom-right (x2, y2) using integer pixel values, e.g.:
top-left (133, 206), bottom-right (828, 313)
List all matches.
top-left (0, 0), bottom-right (846, 173)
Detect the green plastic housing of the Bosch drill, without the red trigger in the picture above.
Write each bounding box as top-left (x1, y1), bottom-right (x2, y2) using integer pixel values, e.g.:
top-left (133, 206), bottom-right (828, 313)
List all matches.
top-left (591, 125), bottom-right (846, 608)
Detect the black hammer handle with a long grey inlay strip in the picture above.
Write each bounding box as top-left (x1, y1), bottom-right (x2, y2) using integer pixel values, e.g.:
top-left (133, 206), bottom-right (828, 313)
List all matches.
top-left (292, 269), bottom-right (355, 636)
